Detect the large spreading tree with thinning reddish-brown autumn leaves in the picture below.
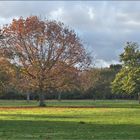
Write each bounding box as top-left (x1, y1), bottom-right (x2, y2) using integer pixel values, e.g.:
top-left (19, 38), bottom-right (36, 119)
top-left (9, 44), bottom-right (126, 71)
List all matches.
top-left (0, 16), bottom-right (90, 106)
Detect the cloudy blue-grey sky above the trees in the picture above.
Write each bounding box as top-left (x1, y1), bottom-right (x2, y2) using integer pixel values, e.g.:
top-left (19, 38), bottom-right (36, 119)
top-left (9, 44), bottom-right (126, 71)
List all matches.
top-left (0, 1), bottom-right (140, 67)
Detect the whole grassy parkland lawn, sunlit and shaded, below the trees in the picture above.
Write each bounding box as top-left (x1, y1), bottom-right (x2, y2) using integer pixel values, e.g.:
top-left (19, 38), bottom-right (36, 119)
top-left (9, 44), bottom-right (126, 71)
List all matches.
top-left (0, 100), bottom-right (140, 140)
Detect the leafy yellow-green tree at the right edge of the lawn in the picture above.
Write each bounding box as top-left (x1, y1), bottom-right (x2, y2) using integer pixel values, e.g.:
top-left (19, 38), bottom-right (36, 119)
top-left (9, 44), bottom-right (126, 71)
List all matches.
top-left (112, 42), bottom-right (140, 103)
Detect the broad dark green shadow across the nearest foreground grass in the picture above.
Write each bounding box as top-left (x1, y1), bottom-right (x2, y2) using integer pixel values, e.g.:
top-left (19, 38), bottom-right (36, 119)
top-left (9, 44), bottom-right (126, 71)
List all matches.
top-left (0, 120), bottom-right (140, 140)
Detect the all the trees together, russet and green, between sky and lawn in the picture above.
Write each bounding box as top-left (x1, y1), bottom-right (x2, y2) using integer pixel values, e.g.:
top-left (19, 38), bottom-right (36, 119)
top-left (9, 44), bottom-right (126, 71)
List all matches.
top-left (0, 16), bottom-right (140, 103)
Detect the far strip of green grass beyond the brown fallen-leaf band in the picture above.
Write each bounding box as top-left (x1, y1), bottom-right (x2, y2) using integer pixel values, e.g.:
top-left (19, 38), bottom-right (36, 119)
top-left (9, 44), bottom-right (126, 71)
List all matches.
top-left (0, 100), bottom-right (140, 108)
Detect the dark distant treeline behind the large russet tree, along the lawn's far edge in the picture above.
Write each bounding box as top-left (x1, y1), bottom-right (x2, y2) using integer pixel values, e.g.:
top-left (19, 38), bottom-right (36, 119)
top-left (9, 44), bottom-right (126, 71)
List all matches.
top-left (0, 64), bottom-right (137, 100)
